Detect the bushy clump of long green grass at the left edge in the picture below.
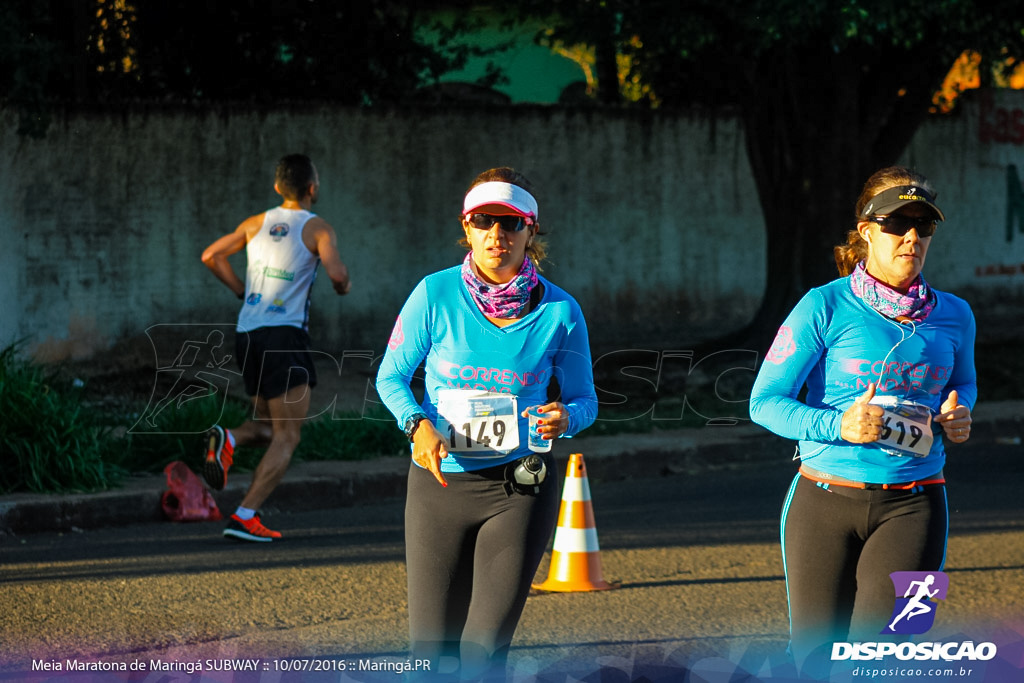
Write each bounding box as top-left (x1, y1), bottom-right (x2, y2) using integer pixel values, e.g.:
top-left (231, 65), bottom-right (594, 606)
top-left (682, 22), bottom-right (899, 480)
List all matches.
top-left (0, 344), bottom-right (124, 494)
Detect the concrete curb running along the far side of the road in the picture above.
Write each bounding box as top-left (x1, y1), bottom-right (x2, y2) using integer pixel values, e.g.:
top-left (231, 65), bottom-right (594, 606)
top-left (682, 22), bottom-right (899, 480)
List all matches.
top-left (0, 401), bottom-right (1024, 536)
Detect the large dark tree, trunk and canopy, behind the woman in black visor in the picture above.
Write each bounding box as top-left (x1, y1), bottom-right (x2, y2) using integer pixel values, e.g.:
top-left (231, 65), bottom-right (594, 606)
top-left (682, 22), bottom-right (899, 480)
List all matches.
top-left (516, 0), bottom-right (1024, 335)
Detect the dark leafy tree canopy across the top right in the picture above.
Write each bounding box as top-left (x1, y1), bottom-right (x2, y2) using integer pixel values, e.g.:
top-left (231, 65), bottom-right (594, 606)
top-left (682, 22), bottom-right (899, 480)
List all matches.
top-left (517, 0), bottom-right (1024, 105)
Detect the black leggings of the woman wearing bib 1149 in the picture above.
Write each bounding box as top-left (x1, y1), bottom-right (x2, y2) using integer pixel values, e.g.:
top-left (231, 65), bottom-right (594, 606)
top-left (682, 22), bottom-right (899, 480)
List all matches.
top-left (406, 456), bottom-right (559, 678)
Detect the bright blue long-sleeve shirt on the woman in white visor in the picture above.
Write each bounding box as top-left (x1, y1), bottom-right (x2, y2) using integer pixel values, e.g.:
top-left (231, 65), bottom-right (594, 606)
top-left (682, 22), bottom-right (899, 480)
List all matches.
top-left (377, 266), bottom-right (597, 472)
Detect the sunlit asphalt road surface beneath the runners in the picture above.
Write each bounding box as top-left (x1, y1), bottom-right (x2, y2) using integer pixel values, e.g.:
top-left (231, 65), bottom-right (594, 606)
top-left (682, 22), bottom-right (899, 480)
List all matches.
top-left (0, 437), bottom-right (1024, 681)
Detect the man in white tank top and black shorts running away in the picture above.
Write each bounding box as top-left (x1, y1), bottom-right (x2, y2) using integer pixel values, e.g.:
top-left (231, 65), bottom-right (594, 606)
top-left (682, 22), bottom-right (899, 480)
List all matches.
top-left (203, 155), bottom-right (349, 542)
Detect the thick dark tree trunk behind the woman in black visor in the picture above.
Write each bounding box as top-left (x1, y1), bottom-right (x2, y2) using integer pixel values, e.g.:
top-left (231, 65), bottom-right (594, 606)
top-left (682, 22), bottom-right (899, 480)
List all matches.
top-left (740, 41), bottom-right (945, 352)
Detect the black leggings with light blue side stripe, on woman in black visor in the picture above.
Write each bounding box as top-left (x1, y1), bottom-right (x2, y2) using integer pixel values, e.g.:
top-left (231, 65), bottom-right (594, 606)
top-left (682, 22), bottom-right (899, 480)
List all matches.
top-left (782, 475), bottom-right (949, 666)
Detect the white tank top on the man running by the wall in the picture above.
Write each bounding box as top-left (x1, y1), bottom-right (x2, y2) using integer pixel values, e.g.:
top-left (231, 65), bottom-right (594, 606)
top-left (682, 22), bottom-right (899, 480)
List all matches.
top-left (238, 207), bottom-right (319, 332)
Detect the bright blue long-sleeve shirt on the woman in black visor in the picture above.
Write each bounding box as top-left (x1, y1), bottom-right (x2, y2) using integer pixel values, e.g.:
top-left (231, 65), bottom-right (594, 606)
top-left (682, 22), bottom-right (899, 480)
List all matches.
top-left (751, 278), bottom-right (978, 483)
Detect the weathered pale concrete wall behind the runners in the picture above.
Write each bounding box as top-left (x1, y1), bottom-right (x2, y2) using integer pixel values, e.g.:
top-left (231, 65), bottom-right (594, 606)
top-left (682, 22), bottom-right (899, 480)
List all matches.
top-left (0, 91), bottom-right (1024, 362)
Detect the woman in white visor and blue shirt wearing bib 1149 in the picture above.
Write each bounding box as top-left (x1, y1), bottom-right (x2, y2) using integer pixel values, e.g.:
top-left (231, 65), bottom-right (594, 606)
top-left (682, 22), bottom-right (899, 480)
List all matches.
top-left (377, 168), bottom-right (597, 680)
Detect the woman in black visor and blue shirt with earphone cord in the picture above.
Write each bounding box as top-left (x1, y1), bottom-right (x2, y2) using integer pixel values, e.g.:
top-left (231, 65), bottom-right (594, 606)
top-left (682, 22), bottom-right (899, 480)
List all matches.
top-left (751, 167), bottom-right (978, 679)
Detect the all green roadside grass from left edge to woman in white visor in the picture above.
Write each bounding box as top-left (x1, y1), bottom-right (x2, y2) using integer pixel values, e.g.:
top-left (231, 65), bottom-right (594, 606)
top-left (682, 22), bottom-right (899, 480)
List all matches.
top-left (0, 344), bottom-right (409, 495)
